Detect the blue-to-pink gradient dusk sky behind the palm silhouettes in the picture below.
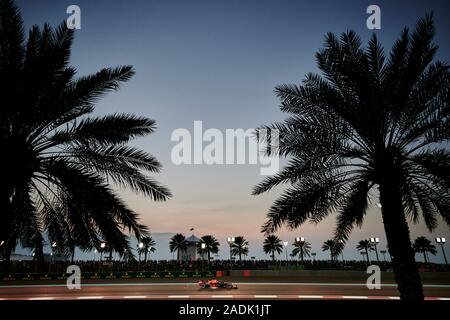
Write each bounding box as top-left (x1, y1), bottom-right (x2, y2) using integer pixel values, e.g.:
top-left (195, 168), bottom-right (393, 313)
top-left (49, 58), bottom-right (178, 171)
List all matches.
top-left (17, 0), bottom-right (450, 261)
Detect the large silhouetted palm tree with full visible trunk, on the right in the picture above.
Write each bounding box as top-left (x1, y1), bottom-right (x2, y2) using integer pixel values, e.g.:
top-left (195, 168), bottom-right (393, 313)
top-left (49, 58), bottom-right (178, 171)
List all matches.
top-left (253, 15), bottom-right (450, 300)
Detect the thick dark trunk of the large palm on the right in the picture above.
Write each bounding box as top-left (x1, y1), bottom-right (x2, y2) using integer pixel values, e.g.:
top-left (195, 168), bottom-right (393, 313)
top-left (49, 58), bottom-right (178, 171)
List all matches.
top-left (379, 179), bottom-right (424, 300)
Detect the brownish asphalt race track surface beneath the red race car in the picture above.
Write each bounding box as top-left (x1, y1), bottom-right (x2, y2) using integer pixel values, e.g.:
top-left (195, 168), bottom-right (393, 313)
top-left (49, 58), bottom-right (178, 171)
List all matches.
top-left (0, 279), bottom-right (450, 300)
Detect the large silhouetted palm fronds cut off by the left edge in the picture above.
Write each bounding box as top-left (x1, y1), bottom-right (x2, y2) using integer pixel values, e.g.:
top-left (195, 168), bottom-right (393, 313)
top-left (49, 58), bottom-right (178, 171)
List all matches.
top-left (0, 0), bottom-right (170, 259)
